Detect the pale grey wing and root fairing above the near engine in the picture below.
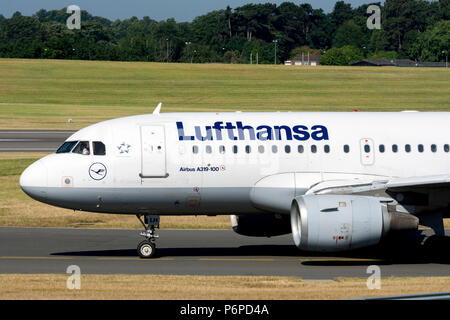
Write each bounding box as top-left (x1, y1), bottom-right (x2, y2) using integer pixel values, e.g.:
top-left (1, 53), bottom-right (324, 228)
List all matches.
top-left (250, 173), bottom-right (450, 215)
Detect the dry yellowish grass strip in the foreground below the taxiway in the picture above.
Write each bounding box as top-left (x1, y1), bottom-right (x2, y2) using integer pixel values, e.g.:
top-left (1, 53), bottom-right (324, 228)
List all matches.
top-left (0, 274), bottom-right (450, 300)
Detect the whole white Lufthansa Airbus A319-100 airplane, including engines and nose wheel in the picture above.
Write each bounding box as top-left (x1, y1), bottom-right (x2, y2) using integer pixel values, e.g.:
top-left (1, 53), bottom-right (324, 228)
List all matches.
top-left (20, 104), bottom-right (450, 258)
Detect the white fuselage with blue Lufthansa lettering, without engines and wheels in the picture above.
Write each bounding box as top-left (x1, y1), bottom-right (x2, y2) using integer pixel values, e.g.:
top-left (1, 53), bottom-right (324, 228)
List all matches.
top-left (20, 112), bottom-right (450, 215)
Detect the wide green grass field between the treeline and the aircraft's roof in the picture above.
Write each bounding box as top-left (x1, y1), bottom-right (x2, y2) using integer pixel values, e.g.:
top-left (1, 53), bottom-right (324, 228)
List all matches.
top-left (0, 59), bottom-right (450, 129)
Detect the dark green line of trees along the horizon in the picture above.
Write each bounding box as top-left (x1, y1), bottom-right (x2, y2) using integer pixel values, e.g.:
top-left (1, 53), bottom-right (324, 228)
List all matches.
top-left (0, 0), bottom-right (450, 65)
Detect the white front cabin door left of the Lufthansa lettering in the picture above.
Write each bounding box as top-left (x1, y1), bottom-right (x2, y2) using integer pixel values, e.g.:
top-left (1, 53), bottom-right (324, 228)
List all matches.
top-left (140, 125), bottom-right (168, 178)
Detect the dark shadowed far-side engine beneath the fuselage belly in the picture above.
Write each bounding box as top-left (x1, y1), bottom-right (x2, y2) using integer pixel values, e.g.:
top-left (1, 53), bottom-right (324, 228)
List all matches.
top-left (231, 214), bottom-right (291, 237)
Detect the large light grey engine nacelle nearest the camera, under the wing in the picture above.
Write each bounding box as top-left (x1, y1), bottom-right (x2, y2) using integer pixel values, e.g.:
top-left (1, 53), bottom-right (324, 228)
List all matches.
top-left (291, 195), bottom-right (419, 252)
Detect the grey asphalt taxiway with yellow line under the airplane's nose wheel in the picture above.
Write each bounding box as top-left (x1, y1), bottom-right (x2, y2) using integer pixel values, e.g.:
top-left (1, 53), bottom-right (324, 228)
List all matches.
top-left (0, 227), bottom-right (450, 280)
